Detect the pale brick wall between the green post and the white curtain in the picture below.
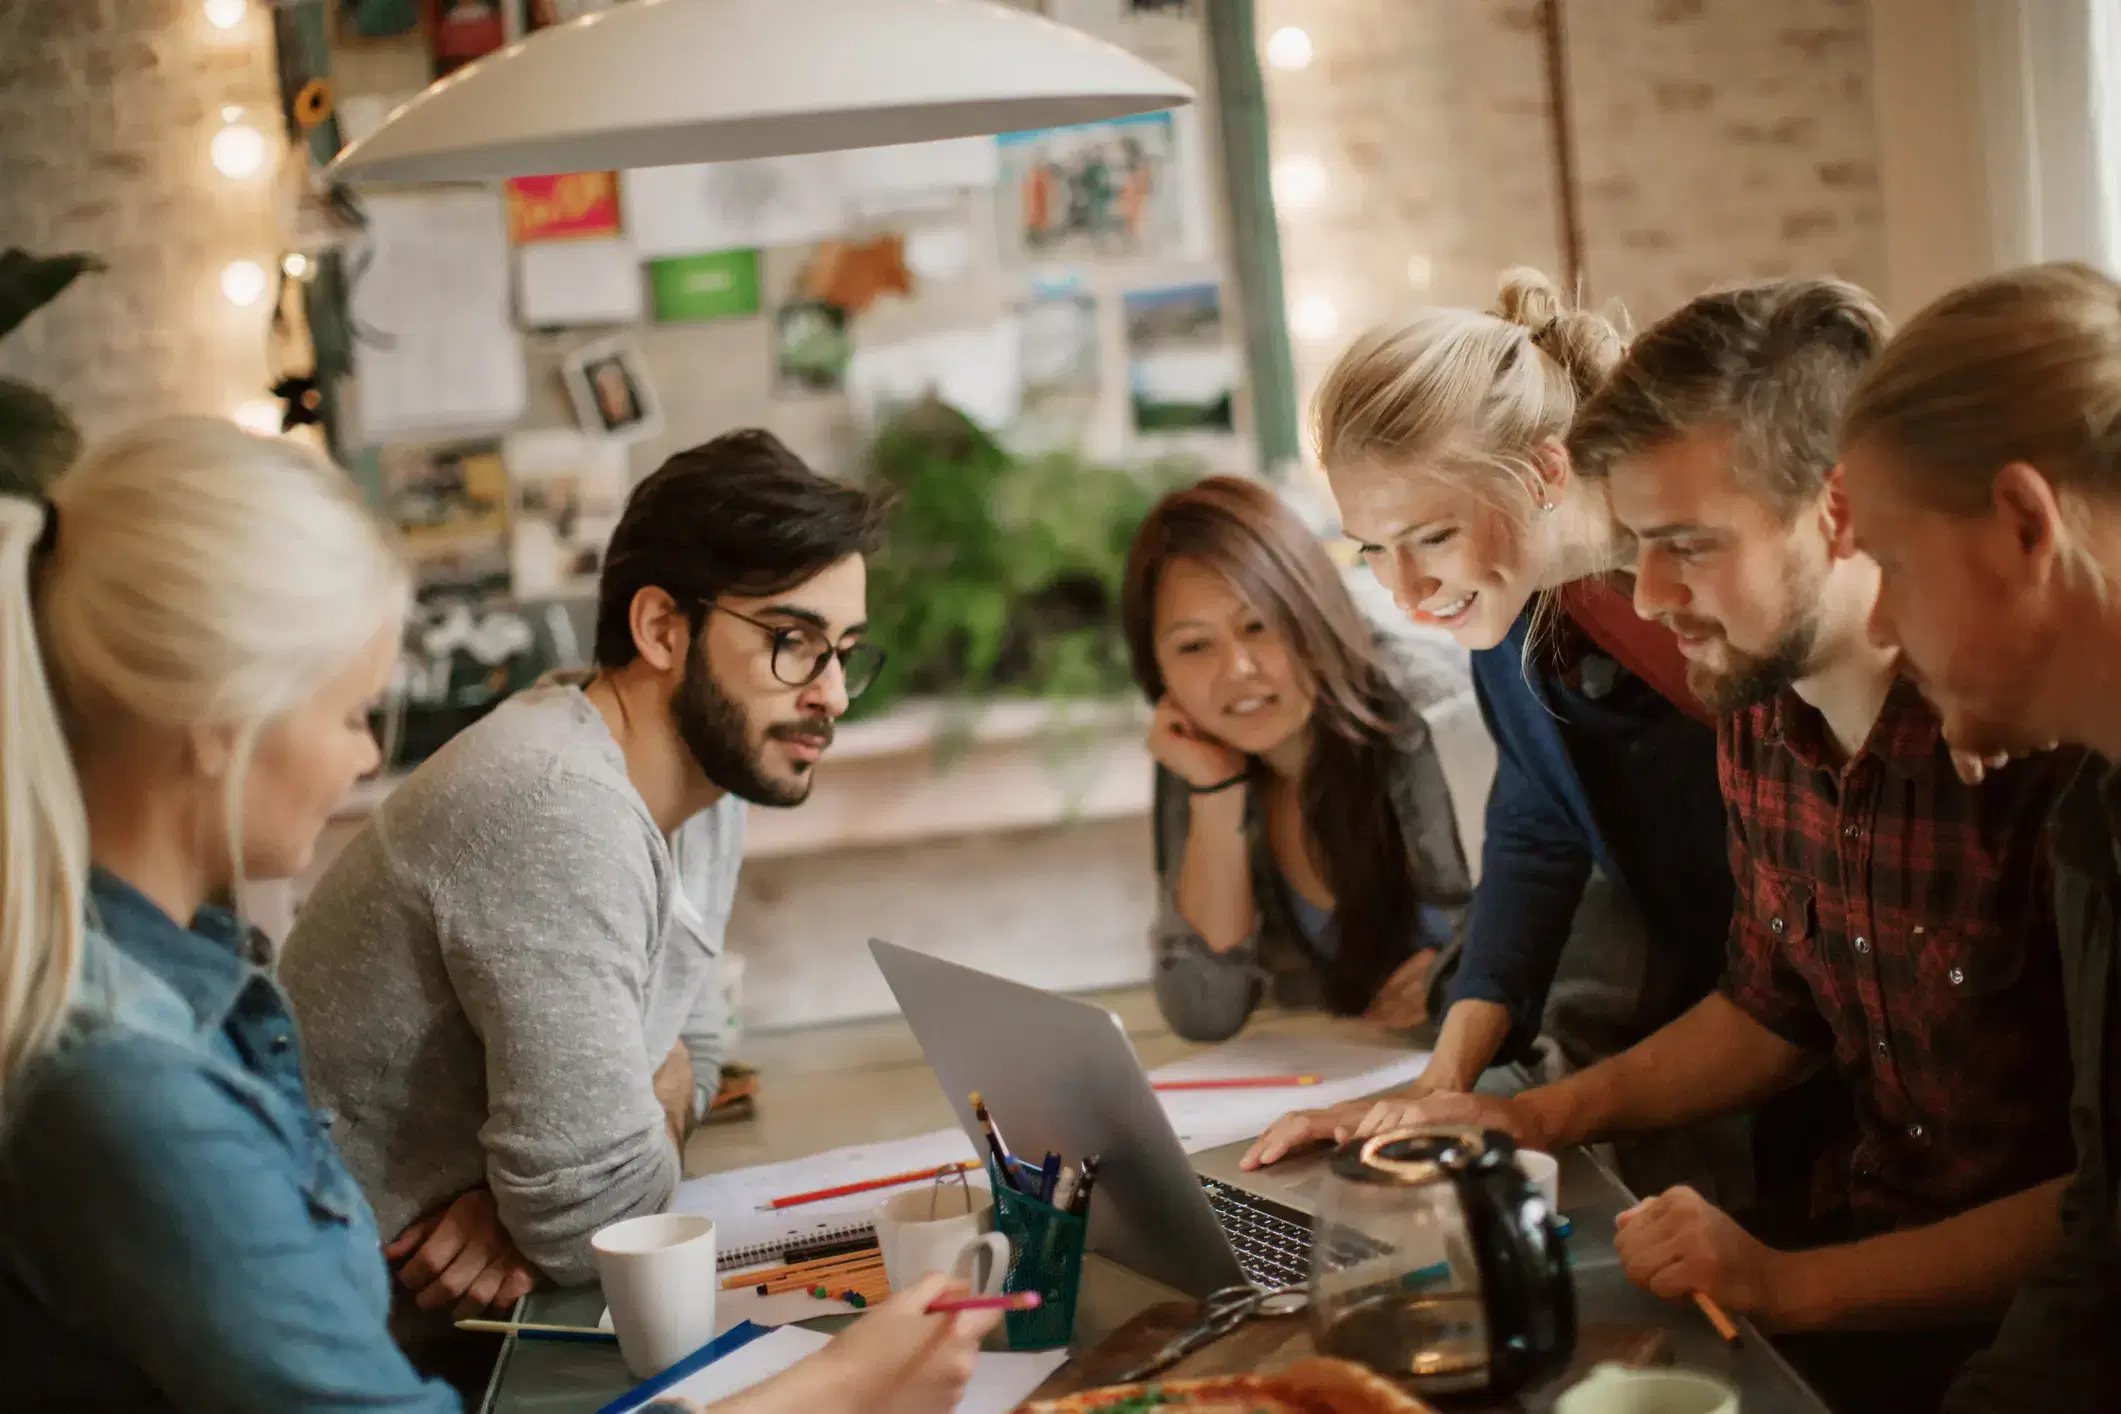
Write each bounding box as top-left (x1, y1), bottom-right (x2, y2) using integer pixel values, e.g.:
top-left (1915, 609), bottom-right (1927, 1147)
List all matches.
top-left (1260, 0), bottom-right (1883, 419)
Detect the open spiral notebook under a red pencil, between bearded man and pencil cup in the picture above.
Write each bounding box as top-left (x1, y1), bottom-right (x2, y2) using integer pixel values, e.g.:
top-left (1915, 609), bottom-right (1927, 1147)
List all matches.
top-left (670, 1130), bottom-right (976, 1272)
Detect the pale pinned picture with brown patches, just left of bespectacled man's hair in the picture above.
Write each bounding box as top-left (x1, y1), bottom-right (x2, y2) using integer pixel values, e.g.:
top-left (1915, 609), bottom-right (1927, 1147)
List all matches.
top-left (501, 428), bottom-right (628, 600)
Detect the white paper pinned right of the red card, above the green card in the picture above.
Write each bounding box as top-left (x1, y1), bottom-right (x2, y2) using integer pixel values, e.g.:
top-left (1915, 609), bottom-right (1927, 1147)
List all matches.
top-left (621, 153), bottom-right (848, 261)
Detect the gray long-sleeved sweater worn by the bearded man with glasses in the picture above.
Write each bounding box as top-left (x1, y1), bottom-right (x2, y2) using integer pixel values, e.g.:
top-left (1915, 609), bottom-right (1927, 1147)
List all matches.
top-left (280, 685), bottom-right (744, 1283)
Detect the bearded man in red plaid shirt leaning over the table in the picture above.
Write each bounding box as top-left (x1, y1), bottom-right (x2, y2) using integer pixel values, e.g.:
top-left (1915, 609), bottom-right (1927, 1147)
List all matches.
top-left (1372, 280), bottom-right (2076, 1414)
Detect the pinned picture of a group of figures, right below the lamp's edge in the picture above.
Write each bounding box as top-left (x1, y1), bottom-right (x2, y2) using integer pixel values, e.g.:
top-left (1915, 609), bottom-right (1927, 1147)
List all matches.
top-left (995, 112), bottom-right (1188, 265)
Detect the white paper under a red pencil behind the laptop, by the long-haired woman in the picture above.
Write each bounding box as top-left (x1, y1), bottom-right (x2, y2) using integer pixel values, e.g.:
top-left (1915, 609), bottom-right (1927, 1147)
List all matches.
top-left (1150, 1035), bottom-right (1430, 1153)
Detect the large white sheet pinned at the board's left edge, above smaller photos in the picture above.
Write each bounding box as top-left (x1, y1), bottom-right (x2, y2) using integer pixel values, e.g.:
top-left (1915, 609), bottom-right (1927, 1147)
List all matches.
top-left (348, 191), bottom-right (528, 441)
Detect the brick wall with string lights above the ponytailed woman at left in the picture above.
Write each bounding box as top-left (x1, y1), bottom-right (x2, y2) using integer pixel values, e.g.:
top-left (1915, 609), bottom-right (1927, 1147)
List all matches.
top-left (0, 0), bottom-right (280, 437)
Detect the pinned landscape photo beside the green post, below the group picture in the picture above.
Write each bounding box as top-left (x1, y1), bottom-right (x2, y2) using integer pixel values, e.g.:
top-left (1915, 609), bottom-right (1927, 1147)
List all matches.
top-left (1126, 284), bottom-right (1243, 432)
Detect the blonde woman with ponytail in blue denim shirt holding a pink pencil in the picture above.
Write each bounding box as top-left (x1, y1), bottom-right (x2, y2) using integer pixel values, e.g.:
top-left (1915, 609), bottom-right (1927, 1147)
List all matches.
top-left (0, 420), bottom-right (988, 1414)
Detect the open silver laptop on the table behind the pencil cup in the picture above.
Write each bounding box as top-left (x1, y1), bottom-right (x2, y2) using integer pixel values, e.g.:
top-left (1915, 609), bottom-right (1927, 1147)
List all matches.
top-left (870, 939), bottom-right (1315, 1295)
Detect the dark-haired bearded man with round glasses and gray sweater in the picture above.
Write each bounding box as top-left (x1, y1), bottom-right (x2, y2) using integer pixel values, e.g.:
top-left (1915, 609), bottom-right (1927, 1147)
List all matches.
top-left (280, 430), bottom-right (884, 1378)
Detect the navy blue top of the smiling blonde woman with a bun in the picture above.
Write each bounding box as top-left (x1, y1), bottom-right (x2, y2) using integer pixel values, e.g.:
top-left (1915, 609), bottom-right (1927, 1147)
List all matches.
top-left (1451, 608), bottom-right (1731, 1064)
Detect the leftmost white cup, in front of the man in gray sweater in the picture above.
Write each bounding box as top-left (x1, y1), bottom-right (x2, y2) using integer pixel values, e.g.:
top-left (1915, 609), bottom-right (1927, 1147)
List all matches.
top-left (590, 1213), bottom-right (715, 1380)
